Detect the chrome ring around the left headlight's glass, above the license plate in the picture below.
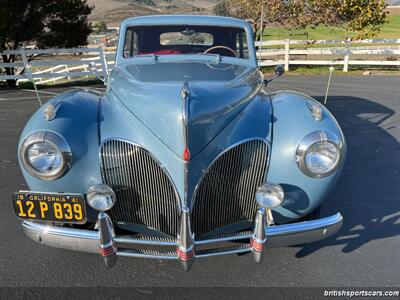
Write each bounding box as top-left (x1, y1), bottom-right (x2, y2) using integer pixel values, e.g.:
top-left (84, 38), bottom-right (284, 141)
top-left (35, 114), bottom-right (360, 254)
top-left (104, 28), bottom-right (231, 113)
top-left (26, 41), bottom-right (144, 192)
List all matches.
top-left (19, 131), bottom-right (72, 180)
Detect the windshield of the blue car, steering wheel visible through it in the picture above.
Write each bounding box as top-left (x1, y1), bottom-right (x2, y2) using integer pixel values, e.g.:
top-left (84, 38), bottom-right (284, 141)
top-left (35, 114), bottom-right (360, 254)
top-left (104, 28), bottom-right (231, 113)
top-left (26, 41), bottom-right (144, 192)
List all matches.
top-left (123, 25), bottom-right (249, 59)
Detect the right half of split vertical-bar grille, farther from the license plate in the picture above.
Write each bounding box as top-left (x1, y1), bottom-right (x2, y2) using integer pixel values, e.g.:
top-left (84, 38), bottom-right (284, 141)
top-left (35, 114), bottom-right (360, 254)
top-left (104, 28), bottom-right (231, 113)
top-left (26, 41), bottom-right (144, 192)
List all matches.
top-left (192, 140), bottom-right (268, 238)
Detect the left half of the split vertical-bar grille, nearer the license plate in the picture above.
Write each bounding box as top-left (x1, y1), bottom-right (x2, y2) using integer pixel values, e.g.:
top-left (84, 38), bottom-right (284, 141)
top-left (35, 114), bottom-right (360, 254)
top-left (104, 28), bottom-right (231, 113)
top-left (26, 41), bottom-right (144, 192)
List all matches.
top-left (100, 140), bottom-right (179, 237)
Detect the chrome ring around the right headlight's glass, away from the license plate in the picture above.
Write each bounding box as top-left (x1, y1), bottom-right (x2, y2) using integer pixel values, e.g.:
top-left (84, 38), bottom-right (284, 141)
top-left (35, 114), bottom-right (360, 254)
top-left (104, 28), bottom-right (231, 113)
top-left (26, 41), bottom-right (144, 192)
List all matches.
top-left (296, 131), bottom-right (343, 178)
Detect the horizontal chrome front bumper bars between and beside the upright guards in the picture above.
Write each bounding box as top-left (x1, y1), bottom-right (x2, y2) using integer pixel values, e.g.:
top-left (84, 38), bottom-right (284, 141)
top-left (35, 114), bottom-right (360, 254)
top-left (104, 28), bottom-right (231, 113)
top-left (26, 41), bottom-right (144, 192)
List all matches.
top-left (22, 213), bottom-right (343, 259)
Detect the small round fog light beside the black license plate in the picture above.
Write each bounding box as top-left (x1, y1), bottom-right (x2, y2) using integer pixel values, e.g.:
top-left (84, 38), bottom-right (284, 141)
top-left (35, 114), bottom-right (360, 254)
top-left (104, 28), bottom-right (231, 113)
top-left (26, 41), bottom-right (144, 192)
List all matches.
top-left (86, 184), bottom-right (115, 211)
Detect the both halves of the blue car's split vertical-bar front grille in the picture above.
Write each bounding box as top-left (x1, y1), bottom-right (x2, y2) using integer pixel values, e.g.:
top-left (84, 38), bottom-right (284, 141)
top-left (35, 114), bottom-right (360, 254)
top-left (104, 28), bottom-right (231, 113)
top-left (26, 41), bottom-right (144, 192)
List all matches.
top-left (100, 139), bottom-right (268, 240)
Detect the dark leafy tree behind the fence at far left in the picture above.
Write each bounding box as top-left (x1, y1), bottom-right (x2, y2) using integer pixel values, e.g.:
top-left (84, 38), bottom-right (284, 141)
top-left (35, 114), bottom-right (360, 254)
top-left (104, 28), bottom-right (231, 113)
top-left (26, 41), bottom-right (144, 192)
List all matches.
top-left (0, 0), bottom-right (93, 85)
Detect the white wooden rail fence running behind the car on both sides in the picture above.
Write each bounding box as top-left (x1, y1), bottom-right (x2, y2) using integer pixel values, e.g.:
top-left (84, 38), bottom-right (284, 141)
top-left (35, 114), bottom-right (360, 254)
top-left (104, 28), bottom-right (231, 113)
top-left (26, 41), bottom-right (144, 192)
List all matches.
top-left (0, 39), bottom-right (400, 83)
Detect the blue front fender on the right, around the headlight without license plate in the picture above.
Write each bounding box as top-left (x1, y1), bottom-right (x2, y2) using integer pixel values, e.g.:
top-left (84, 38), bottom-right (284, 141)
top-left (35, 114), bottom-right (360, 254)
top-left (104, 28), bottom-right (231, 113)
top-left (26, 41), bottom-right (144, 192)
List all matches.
top-left (268, 91), bottom-right (346, 223)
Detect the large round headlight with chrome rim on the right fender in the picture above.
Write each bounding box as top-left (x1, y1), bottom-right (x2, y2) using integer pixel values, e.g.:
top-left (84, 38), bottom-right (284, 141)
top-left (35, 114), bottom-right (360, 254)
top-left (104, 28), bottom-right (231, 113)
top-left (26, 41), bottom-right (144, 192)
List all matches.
top-left (296, 131), bottom-right (343, 178)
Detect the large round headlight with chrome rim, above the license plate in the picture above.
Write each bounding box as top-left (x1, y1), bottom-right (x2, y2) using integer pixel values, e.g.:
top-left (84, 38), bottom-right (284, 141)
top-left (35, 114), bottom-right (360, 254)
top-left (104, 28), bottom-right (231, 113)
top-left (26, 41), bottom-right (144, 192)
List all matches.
top-left (19, 131), bottom-right (72, 180)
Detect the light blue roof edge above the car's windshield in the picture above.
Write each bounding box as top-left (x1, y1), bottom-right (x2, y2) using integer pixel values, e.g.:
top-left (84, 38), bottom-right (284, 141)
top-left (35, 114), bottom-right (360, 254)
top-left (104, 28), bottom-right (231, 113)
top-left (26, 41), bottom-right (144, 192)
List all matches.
top-left (121, 15), bottom-right (252, 29)
